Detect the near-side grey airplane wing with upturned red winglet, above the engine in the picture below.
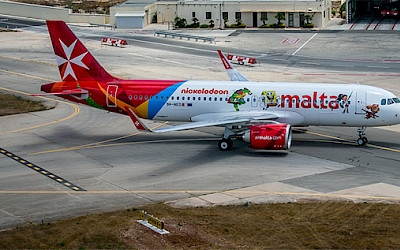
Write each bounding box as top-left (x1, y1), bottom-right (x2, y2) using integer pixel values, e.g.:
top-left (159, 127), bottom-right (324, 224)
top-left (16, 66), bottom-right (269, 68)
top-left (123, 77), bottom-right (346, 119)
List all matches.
top-left (127, 108), bottom-right (279, 133)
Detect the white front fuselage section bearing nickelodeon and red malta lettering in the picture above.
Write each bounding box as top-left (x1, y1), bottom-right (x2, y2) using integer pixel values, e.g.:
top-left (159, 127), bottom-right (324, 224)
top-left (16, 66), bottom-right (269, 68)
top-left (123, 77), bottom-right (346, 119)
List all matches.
top-left (152, 81), bottom-right (400, 127)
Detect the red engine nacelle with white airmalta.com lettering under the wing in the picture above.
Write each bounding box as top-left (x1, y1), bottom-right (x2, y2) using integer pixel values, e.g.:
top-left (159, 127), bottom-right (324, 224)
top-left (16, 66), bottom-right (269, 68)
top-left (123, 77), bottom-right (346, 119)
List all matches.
top-left (242, 123), bottom-right (292, 150)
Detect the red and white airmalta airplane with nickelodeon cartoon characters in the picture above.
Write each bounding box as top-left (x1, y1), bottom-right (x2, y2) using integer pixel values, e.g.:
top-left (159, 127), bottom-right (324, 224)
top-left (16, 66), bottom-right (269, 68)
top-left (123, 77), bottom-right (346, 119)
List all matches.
top-left (35, 21), bottom-right (400, 151)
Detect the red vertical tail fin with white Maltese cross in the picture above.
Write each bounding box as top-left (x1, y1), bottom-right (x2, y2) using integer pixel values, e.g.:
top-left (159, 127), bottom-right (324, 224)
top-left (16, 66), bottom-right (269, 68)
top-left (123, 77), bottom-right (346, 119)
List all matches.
top-left (46, 21), bottom-right (116, 81)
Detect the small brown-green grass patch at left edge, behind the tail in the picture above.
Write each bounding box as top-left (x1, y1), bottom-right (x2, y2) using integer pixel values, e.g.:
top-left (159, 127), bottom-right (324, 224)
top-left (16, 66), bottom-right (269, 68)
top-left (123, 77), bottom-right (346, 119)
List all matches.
top-left (0, 93), bottom-right (46, 116)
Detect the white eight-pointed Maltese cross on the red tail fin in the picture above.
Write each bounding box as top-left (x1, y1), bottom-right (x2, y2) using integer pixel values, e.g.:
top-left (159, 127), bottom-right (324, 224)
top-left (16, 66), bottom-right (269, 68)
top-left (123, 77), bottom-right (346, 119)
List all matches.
top-left (56, 39), bottom-right (89, 80)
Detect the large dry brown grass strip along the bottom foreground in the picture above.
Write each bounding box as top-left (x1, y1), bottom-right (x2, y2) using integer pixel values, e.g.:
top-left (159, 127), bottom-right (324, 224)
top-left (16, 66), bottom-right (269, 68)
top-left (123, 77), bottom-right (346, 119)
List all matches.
top-left (0, 203), bottom-right (400, 249)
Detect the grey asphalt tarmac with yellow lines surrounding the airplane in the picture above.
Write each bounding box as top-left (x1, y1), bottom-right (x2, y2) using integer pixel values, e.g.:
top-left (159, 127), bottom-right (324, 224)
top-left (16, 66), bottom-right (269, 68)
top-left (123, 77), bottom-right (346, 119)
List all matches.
top-left (0, 15), bottom-right (400, 228)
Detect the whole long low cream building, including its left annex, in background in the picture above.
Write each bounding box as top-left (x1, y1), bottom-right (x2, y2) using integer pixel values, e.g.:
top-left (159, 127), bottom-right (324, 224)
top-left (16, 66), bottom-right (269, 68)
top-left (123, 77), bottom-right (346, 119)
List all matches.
top-left (110, 0), bottom-right (332, 28)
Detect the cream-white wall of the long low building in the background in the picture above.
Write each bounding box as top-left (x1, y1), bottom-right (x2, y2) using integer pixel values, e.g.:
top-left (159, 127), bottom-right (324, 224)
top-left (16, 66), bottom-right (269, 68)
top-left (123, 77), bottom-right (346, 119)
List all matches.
top-left (152, 0), bottom-right (331, 27)
